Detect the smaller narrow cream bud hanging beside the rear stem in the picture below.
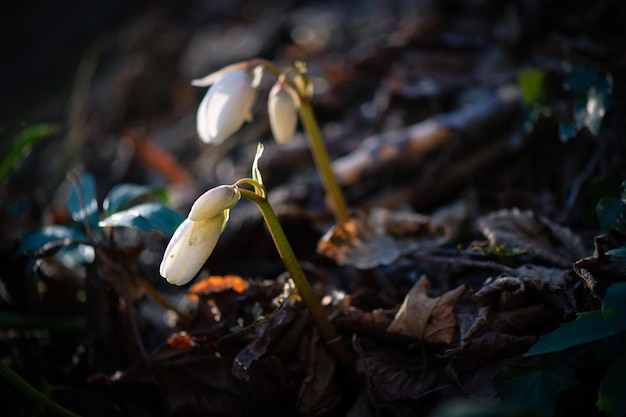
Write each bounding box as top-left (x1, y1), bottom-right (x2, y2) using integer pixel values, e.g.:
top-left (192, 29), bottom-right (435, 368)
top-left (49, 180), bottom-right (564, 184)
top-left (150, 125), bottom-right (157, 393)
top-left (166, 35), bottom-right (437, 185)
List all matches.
top-left (267, 81), bottom-right (298, 145)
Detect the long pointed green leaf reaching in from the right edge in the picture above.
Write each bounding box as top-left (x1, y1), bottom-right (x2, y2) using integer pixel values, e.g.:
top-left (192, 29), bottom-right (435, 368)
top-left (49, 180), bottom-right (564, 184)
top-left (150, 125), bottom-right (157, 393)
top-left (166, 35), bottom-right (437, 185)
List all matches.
top-left (526, 282), bottom-right (626, 356)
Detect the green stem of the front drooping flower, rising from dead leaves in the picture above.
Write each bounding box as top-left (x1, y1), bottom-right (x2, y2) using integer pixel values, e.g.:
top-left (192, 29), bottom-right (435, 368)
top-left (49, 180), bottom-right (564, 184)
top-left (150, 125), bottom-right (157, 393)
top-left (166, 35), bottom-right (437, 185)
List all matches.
top-left (240, 189), bottom-right (352, 369)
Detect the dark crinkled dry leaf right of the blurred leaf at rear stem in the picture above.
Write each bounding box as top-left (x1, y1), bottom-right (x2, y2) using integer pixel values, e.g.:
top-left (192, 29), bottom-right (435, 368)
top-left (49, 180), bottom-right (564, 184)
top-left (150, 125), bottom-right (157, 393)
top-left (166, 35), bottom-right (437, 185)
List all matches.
top-left (478, 209), bottom-right (585, 267)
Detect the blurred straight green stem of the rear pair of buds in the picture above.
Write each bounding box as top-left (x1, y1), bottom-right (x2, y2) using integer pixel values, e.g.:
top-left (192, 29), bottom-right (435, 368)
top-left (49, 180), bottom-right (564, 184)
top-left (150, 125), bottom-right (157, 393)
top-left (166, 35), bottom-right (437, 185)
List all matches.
top-left (300, 100), bottom-right (350, 224)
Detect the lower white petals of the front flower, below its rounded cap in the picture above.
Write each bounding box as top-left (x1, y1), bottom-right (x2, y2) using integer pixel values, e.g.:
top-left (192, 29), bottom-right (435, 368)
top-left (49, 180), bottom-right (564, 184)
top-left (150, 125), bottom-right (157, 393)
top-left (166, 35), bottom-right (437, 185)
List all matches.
top-left (159, 211), bottom-right (228, 285)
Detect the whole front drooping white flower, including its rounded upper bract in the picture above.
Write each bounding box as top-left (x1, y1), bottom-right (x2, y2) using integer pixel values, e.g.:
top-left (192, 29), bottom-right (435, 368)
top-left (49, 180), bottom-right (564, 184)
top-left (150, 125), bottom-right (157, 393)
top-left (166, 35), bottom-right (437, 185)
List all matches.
top-left (159, 185), bottom-right (241, 285)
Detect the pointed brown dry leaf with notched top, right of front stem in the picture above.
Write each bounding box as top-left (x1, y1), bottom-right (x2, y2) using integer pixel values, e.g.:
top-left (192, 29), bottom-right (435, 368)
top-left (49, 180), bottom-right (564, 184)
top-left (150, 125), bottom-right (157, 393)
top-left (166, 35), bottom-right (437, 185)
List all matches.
top-left (387, 276), bottom-right (467, 345)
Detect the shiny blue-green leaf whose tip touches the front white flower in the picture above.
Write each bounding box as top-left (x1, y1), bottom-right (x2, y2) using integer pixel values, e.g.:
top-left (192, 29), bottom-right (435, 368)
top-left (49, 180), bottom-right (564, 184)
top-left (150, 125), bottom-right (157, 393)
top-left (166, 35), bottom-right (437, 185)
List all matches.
top-left (98, 203), bottom-right (185, 236)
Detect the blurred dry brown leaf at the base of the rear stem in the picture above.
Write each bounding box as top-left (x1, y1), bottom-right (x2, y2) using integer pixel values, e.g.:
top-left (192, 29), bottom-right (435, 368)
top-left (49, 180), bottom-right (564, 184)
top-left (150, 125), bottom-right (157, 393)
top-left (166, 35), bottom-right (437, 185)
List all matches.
top-left (317, 208), bottom-right (442, 269)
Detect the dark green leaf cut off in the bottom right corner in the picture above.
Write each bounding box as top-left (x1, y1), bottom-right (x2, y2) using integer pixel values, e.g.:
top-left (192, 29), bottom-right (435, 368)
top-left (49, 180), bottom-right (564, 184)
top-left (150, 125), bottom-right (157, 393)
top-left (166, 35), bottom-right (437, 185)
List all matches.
top-left (596, 354), bottom-right (626, 417)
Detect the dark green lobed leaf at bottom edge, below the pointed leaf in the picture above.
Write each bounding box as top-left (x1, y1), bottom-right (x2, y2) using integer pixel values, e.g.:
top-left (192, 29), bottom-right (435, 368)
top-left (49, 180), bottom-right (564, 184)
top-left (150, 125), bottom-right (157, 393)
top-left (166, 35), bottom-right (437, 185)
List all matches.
top-left (493, 355), bottom-right (578, 416)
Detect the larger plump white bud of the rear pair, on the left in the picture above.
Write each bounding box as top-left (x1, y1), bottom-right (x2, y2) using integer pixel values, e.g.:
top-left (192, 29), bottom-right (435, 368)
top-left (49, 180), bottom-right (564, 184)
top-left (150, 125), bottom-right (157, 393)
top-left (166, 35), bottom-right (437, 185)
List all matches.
top-left (196, 68), bottom-right (257, 144)
